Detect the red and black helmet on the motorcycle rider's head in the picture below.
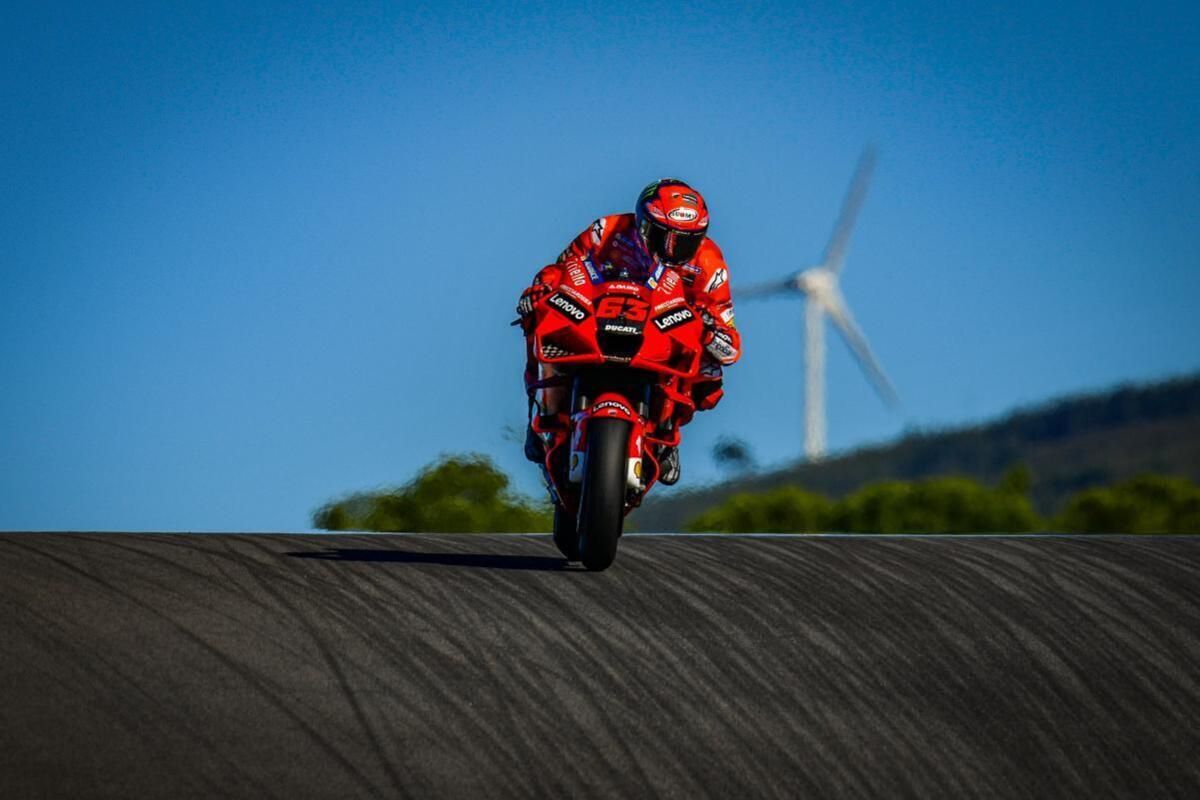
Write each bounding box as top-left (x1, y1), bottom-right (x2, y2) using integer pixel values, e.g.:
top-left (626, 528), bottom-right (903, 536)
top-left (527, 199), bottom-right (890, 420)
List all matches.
top-left (635, 178), bottom-right (708, 264)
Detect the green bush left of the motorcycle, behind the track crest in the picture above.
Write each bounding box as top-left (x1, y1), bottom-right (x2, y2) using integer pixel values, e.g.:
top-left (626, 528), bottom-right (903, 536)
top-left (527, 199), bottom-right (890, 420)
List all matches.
top-left (313, 455), bottom-right (551, 533)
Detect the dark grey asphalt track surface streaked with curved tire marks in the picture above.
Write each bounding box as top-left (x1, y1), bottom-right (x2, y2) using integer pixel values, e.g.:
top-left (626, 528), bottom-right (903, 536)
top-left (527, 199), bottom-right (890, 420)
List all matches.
top-left (0, 534), bottom-right (1200, 799)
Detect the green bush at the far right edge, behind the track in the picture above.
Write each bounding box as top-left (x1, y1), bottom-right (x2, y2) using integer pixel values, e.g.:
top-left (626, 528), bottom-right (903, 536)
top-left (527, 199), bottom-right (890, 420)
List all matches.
top-left (1055, 475), bottom-right (1200, 534)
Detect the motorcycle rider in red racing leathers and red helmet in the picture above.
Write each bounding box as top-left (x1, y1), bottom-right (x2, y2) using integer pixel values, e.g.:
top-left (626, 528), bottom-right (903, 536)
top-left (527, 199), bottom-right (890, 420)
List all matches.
top-left (517, 178), bottom-right (742, 486)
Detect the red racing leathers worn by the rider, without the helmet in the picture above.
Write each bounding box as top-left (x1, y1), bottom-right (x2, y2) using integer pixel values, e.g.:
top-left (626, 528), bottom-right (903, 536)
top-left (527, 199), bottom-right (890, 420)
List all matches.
top-left (522, 213), bottom-right (742, 410)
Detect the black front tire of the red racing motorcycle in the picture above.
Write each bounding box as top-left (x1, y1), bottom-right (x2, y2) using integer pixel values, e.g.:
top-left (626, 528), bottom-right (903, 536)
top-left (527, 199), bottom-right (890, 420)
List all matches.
top-left (580, 417), bottom-right (630, 571)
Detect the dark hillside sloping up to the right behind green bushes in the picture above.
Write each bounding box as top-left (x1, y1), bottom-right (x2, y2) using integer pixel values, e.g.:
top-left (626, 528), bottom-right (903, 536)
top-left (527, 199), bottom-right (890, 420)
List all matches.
top-left (631, 374), bottom-right (1200, 531)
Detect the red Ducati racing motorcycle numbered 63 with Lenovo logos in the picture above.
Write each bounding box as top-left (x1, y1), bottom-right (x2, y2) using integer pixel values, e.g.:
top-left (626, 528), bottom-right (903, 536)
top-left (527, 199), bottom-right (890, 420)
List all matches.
top-left (528, 264), bottom-right (703, 570)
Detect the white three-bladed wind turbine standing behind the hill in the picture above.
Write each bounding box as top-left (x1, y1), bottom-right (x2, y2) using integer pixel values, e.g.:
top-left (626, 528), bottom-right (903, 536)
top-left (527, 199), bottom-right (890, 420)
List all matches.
top-left (737, 148), bottom-right (899, 461)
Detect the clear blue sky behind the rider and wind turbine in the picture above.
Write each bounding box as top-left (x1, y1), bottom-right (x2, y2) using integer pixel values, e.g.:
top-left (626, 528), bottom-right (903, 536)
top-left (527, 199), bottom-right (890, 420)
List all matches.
top-left (0, 2), bottom-right (1200, 530)
